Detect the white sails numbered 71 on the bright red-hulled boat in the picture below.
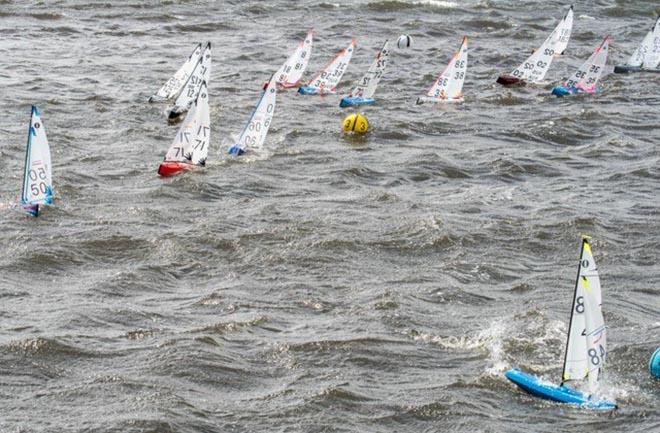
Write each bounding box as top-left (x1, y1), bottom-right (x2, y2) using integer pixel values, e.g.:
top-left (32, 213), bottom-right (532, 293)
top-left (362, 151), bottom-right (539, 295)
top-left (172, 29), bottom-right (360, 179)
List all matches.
top-left (165, 82), bottom-right (211, 165)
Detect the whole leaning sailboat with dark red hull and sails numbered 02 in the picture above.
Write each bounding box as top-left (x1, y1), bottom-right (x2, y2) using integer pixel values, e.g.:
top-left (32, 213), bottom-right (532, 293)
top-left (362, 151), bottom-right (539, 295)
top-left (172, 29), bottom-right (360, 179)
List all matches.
top-left (497, 6), bottom-right (573, 86)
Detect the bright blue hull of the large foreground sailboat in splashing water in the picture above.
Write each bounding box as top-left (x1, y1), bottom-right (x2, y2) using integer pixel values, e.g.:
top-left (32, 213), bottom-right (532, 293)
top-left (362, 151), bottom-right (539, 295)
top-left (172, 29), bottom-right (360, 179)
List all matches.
top-left (504, 368), bottom-right (617, 410)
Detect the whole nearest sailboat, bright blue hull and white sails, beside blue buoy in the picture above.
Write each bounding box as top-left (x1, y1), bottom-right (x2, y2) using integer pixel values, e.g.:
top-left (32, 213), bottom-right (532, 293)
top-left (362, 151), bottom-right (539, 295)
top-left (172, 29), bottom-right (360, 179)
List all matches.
top-left (505, 236), bottom-right (617, 410)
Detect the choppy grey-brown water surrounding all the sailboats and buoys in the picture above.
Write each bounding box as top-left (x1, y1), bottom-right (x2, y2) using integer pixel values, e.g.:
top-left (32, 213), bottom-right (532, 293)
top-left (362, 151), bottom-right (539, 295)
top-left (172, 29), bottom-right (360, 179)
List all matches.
top-left (0, 0), bottom-right (660, 432)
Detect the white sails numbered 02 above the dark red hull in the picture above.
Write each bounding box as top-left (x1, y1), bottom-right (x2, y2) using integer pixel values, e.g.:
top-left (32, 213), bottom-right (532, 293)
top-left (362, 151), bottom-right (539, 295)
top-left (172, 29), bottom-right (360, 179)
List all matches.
top-left (511, 9), bottom-right (573, 84)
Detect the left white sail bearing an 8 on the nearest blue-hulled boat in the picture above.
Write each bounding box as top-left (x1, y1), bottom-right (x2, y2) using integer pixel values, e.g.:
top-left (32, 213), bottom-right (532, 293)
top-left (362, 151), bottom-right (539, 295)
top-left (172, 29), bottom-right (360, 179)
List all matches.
top-left (562, 238), bottom-right (601, 382)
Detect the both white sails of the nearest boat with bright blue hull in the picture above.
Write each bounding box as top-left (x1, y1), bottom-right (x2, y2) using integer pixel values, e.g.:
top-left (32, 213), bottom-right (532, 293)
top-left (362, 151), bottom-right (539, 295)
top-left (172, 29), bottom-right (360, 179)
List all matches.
top-left (562, 237), bottom-right (607, 389)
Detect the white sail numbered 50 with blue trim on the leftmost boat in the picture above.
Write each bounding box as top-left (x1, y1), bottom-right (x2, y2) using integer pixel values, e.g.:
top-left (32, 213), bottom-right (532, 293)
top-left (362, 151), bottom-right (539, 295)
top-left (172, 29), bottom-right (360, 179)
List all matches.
top-left (21, 105), bottom-right (53, 204)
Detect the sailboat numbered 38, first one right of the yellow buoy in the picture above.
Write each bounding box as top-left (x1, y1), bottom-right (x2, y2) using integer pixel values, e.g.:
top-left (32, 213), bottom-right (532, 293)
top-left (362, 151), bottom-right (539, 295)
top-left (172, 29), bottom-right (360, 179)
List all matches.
top-left (417, 36), bottom-right (468, 104)
